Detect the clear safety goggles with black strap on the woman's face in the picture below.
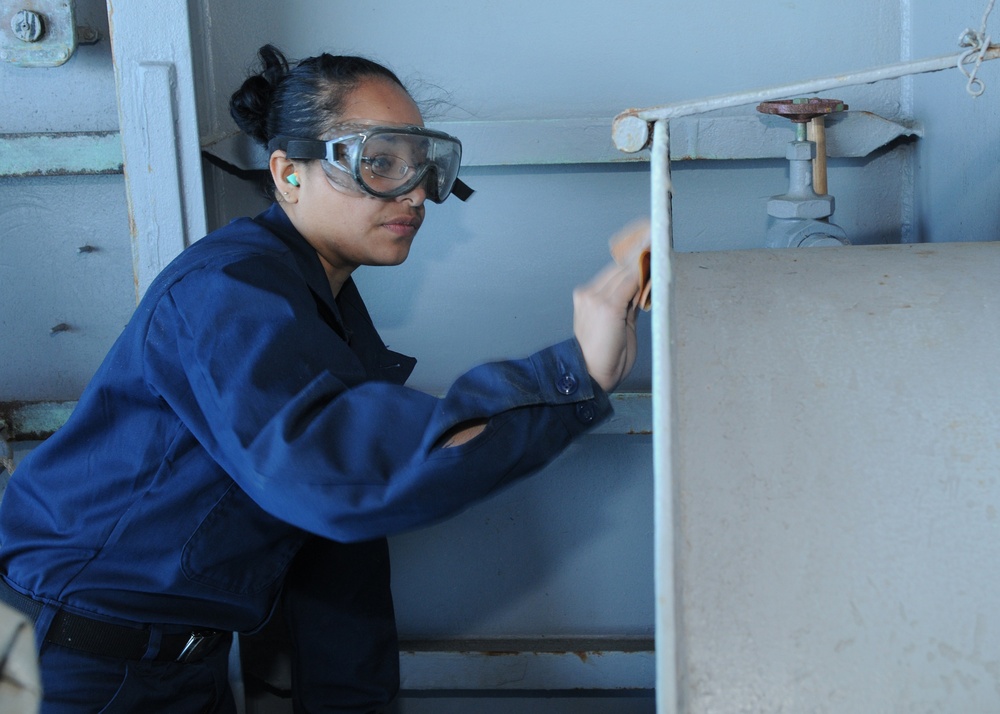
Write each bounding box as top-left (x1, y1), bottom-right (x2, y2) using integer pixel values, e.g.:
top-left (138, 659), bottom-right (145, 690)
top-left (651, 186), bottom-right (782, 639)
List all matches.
top-left (268, 124), bottom-right (473, 203)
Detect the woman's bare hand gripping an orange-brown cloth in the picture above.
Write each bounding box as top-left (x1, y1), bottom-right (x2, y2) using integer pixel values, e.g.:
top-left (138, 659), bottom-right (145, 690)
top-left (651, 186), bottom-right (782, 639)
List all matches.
top-left (573, 264), bottom-right (639, 392)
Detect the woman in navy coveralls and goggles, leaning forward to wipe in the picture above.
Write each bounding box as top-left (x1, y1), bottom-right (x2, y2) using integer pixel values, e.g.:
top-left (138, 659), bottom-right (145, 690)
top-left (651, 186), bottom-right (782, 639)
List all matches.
top-left (0, 46), bottom-right (638, 714)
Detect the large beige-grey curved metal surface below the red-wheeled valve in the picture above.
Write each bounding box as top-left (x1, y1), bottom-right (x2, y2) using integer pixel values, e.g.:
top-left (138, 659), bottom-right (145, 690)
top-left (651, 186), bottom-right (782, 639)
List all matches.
top-left (673, 243), bottom-right (1000, 714)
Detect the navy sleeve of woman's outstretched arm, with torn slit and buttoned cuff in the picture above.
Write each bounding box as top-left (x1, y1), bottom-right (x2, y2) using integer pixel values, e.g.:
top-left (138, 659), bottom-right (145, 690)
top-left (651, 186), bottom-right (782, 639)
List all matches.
top-left (145, 253), bottom-right (611, 542)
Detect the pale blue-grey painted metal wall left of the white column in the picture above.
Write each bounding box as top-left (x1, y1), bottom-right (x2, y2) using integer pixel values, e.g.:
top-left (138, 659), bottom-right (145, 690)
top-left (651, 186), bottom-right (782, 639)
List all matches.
top-left (0, 0), bottom-right (135, 401)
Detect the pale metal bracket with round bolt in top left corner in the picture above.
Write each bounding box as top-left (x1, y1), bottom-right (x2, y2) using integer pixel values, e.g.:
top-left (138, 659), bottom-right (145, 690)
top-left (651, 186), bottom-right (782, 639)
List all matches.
top-left (0, 0), bottom-right (84, 67)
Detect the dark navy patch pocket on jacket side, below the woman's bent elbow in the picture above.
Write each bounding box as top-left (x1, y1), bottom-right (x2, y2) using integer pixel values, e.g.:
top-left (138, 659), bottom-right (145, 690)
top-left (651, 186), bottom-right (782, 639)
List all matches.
top-left (181, 483), bottom-right (310, 595)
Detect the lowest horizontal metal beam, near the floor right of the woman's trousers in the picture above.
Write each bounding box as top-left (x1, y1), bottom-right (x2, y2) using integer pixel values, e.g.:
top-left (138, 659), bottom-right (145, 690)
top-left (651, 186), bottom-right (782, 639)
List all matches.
top-left (399, 638), bottom-right (656, 691)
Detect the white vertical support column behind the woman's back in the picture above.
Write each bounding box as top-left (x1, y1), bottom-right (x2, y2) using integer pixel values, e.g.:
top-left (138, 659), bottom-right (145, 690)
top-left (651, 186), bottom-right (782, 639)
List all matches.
top-left (108, 0), bottom-right (206, 299)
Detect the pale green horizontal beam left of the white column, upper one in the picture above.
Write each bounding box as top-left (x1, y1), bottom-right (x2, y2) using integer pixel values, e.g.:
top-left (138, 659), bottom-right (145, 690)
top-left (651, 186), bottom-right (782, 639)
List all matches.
top-left (0, 131), bottom-right (122, 177)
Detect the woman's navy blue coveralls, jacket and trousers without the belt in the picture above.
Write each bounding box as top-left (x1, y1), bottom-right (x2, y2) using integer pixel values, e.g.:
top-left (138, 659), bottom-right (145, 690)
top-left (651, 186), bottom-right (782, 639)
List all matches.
top-left (0, 204), bottom-right (611, 712)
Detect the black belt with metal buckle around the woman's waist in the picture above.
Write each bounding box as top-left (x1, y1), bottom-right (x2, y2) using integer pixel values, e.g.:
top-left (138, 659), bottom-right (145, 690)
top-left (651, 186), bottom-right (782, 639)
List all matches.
top-left (0, 578), bottom-right (231, 662)
